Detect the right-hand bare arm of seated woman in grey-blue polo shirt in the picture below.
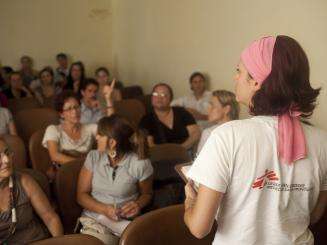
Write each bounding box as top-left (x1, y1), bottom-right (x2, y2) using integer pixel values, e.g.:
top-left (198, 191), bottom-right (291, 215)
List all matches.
top-left (120, 175), bottom-right (153, 218)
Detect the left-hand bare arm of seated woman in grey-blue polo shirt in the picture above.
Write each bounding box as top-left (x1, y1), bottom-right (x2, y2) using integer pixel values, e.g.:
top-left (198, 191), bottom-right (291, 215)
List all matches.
top-left (77, 167), bottom-right (118, 220)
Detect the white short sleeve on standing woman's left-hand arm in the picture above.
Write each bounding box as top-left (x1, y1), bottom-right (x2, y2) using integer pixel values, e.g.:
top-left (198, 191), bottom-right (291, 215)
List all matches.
top-left (187, 127), bottom-right (233, 193)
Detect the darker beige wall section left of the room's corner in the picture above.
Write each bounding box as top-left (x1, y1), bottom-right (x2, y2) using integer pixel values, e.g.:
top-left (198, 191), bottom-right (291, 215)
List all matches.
top-left (0, 0), bottom-right (112, 73)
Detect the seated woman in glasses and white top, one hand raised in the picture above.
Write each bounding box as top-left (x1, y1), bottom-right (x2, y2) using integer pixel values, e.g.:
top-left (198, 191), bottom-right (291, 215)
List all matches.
top-left (42, 82), bottom-right (115, 169)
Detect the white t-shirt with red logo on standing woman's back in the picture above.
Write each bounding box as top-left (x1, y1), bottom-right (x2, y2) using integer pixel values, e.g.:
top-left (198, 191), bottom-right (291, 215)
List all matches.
top-left (188, 116), bottom-right (327, 245)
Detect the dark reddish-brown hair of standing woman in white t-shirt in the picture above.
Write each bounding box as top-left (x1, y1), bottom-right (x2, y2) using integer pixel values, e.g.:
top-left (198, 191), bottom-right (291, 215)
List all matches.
top-left (250, 36), bottom-right (320, 118)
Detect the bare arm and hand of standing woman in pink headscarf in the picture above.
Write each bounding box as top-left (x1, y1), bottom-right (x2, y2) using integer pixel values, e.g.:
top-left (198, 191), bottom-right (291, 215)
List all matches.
top-left (184, 182), bottom-right (223, 239)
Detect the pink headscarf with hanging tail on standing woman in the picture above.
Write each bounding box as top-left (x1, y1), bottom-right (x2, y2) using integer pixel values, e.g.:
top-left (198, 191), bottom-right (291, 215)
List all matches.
top-left (241, 36), bottom-right (307, 164)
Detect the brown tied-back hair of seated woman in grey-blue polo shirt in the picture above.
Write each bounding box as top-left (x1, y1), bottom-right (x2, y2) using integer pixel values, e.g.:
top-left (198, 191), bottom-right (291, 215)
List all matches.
top-left (98, 114), bottom-right (148, 159)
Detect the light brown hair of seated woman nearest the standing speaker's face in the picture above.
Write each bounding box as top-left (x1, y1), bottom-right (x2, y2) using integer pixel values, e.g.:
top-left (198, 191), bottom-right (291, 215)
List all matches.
top-left (212, 90), bottom-right (240, 120)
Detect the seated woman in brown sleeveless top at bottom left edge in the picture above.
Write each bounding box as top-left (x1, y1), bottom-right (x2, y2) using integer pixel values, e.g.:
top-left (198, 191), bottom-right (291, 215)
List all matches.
top-left (0, 139), bottom-right (63, 244)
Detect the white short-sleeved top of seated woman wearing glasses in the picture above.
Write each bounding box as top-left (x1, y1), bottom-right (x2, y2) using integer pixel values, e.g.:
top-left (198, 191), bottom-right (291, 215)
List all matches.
top-left (42, 124), bottom-right (98, 153)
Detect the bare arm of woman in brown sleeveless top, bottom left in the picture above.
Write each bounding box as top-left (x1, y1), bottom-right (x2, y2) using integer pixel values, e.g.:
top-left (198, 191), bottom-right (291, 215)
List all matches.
top-left (21, 174), bottom-right (64, 237)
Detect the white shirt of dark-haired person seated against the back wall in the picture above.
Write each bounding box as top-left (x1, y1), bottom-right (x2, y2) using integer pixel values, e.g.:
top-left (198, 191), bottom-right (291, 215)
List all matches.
top-left (171, 91), bottom-right (212, 129)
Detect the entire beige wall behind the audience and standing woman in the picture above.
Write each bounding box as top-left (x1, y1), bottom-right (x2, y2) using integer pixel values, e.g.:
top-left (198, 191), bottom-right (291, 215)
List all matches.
top-left (0, 0), bottom-right (327, 129)
